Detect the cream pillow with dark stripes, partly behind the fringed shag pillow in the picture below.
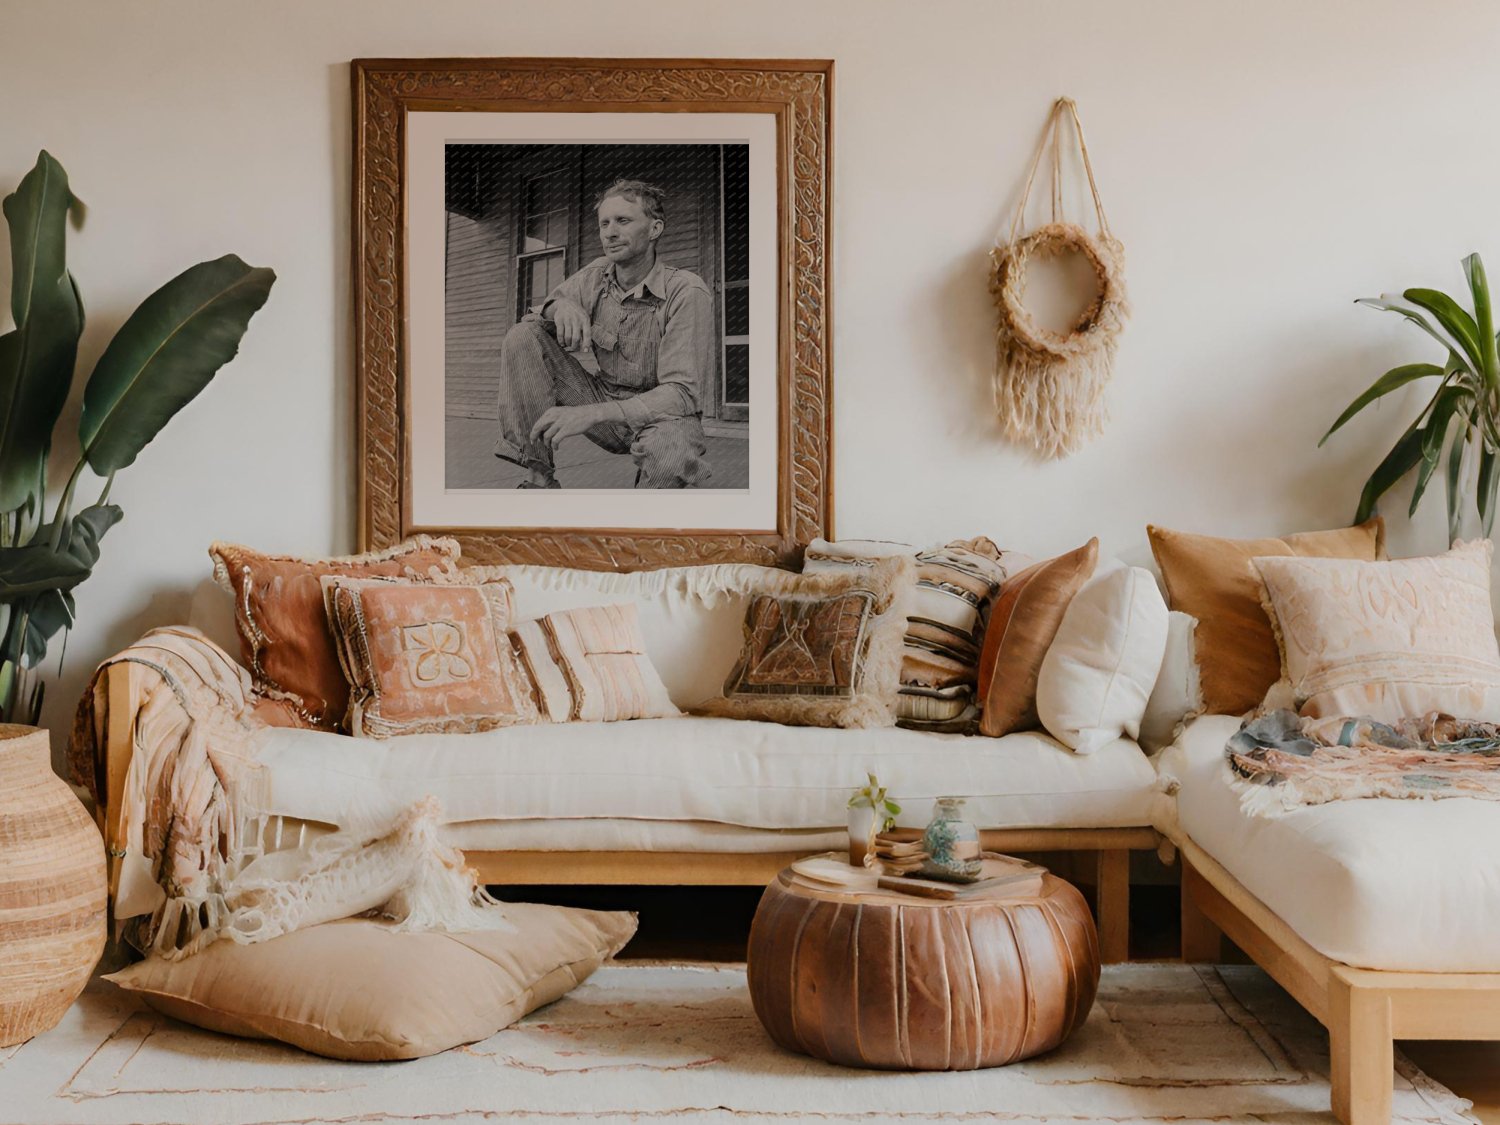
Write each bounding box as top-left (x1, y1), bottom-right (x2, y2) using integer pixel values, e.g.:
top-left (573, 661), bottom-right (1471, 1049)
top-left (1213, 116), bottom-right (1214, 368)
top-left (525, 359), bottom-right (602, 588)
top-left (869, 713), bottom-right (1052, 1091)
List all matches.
top-left (803, 536), bottom-right (1031, 731)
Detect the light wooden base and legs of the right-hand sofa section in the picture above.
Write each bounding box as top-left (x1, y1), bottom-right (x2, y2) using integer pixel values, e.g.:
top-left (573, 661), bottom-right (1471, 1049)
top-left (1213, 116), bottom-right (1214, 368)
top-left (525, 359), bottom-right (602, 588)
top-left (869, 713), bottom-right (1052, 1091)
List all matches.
top-left (1178, 840), bottom-right (1500, 1125)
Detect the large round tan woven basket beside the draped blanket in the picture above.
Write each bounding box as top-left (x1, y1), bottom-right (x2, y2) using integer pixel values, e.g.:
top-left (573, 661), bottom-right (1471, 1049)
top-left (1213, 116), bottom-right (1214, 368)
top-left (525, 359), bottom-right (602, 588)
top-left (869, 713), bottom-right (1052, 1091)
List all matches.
top-left (0, 725), bottom-right (107, 1047)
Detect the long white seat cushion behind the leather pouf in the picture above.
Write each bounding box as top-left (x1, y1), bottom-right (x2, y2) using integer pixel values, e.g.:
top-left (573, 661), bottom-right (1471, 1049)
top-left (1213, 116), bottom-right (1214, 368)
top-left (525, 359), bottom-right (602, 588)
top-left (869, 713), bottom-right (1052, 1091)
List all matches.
top-left (254, 717), bottom-right (1157, 828)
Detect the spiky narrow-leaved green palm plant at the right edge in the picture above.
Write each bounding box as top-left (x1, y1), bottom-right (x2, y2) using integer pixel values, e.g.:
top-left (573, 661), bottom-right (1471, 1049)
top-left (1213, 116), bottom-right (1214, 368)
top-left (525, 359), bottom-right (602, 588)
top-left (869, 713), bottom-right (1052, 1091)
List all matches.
top-left (1319, 254), bottom-right (1500, 543)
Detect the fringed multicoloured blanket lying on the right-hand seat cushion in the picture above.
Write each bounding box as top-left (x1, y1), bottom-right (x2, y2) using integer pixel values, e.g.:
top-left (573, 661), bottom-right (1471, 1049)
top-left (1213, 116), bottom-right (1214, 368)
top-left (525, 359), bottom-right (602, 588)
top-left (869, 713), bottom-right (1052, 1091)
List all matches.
top-left (1224, 711), bottom-right (1500, 816)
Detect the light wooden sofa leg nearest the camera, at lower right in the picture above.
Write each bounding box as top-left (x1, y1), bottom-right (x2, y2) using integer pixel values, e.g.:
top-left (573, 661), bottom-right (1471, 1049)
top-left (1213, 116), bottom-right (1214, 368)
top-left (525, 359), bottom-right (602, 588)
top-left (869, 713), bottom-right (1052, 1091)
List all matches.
top-left (1328, 969), bottom-right (1395, 1125)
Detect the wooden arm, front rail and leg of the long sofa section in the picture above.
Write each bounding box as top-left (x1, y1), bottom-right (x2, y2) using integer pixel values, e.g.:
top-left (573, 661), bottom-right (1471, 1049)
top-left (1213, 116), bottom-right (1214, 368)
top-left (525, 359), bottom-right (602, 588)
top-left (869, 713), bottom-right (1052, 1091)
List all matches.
top-left (98, 662), bottom-right (1161, 965)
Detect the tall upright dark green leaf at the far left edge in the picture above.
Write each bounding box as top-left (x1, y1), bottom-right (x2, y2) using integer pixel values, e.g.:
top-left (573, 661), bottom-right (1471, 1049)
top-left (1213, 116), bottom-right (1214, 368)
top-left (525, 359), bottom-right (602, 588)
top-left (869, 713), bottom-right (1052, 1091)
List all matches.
top-left (0, 152), bottom-right (84, 512)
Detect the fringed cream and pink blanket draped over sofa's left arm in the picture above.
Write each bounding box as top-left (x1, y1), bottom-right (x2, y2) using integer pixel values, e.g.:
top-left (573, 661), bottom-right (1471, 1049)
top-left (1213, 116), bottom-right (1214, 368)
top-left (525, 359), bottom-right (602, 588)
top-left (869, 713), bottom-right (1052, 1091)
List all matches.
top-left (68, 629), bottom-right (507, 959)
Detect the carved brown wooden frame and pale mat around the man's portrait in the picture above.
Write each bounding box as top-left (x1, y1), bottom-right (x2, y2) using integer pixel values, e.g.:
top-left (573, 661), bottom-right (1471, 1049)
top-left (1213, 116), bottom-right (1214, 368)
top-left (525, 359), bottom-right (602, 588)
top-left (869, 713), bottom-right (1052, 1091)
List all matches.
top-left (353, 59), bottom-right (833, 570)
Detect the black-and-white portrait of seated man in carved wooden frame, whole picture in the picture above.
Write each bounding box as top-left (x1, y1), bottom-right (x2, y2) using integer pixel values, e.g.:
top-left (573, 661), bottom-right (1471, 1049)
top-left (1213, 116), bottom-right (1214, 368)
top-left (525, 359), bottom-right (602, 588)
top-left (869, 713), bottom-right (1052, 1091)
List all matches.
top-left (356, 60), bottom-right (831, 567)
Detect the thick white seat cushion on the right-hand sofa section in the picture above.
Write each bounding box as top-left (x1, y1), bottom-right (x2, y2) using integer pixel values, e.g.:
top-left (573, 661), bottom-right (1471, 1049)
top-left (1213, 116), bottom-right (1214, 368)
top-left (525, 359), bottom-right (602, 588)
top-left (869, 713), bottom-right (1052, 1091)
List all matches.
top-left (1158, 716), bottom-right (1500, 972)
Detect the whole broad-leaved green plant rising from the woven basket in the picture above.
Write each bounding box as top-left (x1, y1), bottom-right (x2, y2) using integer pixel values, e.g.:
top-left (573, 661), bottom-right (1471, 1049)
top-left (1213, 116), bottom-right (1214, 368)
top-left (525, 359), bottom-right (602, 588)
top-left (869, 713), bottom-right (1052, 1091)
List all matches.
top-left (0, 152), bottom-right (276, 725)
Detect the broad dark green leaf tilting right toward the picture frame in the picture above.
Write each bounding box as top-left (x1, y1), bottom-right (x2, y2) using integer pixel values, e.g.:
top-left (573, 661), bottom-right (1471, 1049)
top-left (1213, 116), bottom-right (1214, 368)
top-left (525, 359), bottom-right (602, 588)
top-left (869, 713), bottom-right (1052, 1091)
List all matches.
top-left (78, 254), bottom-right (276, 477)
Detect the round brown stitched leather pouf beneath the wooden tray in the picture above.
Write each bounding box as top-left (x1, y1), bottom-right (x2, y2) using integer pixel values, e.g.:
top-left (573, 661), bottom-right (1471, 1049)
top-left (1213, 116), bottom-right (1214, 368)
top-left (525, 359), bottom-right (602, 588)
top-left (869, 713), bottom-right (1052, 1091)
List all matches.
top-left (749, 870), bottom-right (1100, 1071)
